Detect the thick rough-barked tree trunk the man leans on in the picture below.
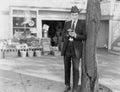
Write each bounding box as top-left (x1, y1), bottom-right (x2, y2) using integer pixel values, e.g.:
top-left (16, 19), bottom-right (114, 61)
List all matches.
top-left (79, 0), bottom-right (101, 92)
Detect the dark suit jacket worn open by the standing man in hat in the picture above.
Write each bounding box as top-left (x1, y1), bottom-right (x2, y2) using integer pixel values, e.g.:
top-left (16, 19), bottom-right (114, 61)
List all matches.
top-left (61, 20), bottom-right (86, 58)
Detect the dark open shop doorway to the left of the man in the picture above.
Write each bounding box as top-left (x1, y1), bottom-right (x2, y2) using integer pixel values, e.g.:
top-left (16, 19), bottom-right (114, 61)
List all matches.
top-left (42, 20), bottom-right (65, 49)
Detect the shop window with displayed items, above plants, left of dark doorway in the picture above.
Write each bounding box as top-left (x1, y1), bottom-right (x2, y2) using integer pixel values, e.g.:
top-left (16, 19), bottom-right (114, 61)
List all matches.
top-left (12, 10), bottom-right (37, 36)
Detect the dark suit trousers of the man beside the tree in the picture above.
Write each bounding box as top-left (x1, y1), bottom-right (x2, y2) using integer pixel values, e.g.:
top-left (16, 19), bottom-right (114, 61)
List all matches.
top-left (64, 49), bottom-right (80, 89)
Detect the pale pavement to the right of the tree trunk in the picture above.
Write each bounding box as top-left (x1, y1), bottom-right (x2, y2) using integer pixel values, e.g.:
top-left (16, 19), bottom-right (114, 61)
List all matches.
top-left (97, 50), bottom-right (120, 92)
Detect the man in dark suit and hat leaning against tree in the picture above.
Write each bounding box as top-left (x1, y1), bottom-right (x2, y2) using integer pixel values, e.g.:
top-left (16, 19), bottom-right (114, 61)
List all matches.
top-left (61, 6), bottom-right (86, 92)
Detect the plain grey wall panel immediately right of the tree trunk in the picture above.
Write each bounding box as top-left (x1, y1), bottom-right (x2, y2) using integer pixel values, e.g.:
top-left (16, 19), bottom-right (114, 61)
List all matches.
top-left (97, 21), bottom-right (109, 47)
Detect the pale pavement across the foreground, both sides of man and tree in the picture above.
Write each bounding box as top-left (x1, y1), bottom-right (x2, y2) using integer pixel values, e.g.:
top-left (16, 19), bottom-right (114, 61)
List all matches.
top-left (0, 49), bottom-right (120, 92)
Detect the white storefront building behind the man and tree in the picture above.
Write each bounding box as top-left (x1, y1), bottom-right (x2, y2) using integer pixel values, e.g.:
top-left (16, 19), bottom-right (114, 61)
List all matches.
top-left (0, 0), bottom-right (120, 50)
